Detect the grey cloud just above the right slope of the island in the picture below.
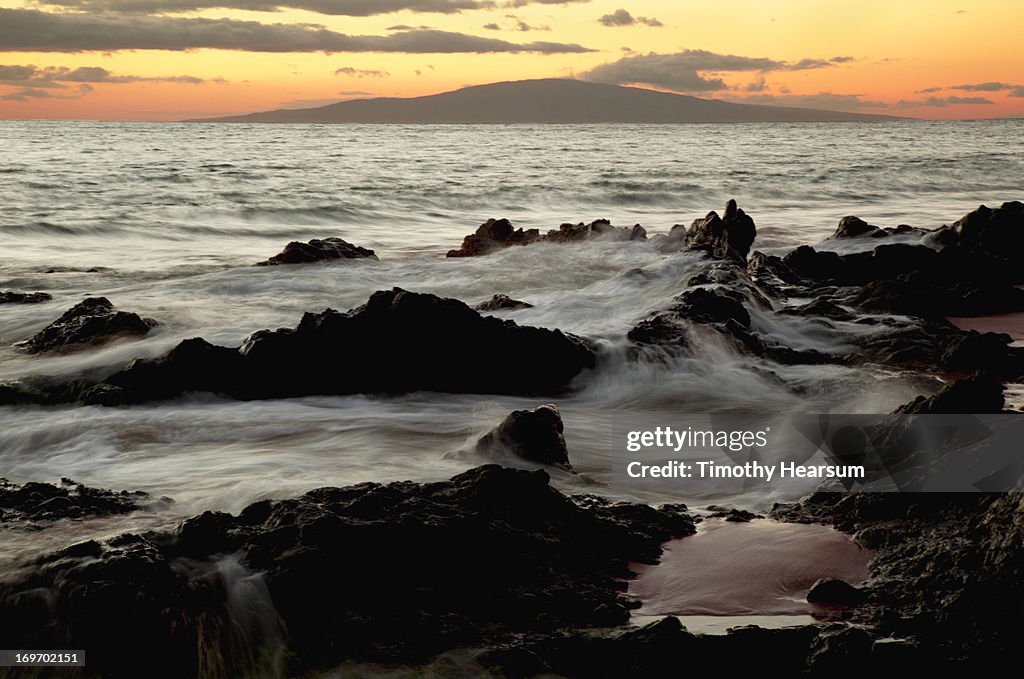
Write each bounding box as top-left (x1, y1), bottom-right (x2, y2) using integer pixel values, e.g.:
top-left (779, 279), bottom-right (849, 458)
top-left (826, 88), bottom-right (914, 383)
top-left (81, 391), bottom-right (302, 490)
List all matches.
top-left (581, 49), bottom-right (834, 92)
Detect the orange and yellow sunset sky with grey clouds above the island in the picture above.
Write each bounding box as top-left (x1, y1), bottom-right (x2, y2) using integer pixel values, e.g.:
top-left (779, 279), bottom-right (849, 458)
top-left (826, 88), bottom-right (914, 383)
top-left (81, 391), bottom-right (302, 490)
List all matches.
top-left (0, 0), bottom-right (1024, 120)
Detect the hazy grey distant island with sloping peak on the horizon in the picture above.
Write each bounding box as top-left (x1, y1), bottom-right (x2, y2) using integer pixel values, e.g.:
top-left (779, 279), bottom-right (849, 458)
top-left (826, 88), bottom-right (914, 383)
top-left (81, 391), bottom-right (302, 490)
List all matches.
top-left (185, 79), bottom-right (902, 124)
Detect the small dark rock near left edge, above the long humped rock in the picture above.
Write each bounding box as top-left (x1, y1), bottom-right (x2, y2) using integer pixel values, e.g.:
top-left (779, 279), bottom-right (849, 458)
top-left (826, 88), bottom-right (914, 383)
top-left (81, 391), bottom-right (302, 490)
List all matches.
top-left (17, 297), bottom-right (159, 353)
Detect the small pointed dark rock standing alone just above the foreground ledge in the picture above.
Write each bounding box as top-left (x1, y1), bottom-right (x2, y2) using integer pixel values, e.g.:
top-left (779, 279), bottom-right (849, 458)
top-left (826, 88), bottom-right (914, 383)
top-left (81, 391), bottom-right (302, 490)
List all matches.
top-left (476, 404), bottom-right (572, 471)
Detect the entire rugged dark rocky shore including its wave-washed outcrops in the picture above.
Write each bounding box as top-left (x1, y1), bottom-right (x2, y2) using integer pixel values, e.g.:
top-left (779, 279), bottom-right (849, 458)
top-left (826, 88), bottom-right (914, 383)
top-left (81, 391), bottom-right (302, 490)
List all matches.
top-left (0, 202), bottom-right (1024, 677)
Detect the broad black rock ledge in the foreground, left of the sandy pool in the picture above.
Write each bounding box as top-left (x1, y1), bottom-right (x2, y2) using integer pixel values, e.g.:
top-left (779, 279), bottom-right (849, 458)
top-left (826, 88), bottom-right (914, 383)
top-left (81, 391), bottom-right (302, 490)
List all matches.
top-left (0, 465), bottom-right (693, 677)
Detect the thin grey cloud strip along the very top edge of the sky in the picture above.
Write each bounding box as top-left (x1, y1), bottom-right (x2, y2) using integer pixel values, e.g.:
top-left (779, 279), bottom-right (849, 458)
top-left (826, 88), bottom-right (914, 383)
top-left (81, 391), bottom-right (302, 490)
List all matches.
top-left (36, 0), bottom-right (589, 16)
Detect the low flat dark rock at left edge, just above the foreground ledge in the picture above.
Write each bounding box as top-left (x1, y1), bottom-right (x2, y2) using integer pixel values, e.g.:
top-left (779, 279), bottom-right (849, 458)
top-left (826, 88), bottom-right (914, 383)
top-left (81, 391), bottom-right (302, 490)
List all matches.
top-left (0, 478), bottom-right (157, 528)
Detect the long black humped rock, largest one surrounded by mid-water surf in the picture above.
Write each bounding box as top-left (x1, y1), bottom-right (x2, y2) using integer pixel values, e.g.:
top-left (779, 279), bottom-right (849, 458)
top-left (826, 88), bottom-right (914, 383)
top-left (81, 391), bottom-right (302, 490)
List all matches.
top-left (95, 288), bottom-right (596, 402)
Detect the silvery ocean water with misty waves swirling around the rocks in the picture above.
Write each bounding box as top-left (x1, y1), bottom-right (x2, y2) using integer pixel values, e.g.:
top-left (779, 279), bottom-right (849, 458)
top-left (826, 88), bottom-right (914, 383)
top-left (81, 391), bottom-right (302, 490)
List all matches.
top-left (0, 121), bottom-right (1024, 565)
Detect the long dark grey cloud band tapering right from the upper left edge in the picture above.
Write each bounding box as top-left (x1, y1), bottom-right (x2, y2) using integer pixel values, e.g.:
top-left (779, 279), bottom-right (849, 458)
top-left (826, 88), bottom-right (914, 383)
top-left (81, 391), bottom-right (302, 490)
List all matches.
top-left (0, 8), bottom-right (593, 54)
